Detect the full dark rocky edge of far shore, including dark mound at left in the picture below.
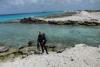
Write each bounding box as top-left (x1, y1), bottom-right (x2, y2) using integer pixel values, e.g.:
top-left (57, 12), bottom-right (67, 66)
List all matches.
top-left (2, 17), bottom-right (100, 26)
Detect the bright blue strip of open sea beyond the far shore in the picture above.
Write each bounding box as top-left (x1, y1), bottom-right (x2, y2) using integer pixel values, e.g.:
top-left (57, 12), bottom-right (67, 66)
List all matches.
top-left (0, 11), bottom-right (63, 22)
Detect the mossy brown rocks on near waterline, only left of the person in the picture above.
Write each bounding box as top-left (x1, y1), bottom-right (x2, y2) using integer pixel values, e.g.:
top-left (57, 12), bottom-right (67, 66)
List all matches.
top-left (0, 41), bottom-right (36, 60)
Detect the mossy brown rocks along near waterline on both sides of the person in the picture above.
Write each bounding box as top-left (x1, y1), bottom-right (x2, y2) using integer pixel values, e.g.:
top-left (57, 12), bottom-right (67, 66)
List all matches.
top-left (0, 41), bottom-right (64, 61)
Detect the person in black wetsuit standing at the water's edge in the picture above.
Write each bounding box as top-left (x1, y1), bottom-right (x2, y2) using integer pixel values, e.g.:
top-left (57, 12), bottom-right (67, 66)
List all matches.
top-left (37, 32), bottom-right (48, 54)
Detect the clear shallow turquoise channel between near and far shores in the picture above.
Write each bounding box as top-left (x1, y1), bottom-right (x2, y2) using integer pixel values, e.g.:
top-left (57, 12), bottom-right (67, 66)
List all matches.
top-left (0, 24), bottom-right (100, 47)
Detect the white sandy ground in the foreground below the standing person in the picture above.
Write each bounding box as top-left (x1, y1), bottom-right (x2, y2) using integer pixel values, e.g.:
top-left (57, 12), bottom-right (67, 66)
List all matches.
top-left (0, 44), bottom-right (100, 67)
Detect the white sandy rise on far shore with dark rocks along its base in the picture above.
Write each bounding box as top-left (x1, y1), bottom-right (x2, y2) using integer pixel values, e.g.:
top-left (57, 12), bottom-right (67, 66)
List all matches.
top-left (42, 11), bottom-right (100, 26)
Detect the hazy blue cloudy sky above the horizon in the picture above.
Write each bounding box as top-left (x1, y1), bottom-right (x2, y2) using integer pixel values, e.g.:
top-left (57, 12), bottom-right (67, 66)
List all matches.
top-left (0, 0), bottom-right (100, 14)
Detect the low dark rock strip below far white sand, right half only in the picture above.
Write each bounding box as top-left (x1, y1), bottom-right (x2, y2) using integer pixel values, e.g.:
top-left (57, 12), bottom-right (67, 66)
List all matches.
top-left (48, 20), bottom-right (100, 26)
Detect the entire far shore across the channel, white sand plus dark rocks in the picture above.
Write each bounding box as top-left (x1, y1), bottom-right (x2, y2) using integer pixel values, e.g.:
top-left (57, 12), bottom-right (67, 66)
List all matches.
top-left (1, 11), bottom-right (100, 26)
